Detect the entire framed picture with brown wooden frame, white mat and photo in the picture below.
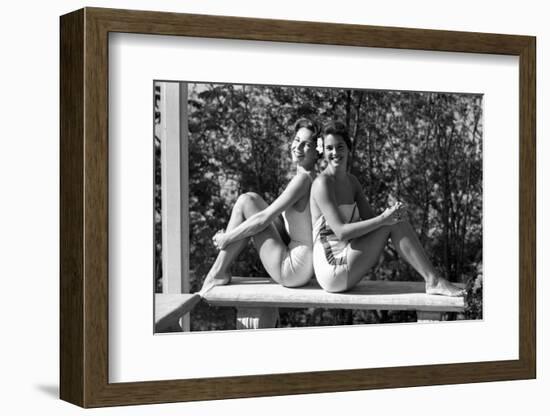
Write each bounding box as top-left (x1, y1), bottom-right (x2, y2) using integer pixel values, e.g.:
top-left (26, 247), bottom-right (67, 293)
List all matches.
top-left (60, 8), bottom-right (536, 407)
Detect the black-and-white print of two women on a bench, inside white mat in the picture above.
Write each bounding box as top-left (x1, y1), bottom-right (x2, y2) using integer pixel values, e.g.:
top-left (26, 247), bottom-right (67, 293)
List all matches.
top-left (153, 81), bottom-right (483, 333)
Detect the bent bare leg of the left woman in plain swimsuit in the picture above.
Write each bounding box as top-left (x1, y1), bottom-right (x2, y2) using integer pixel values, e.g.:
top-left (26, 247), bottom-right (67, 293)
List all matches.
top-left (203, 192), bottom-right (286, 288)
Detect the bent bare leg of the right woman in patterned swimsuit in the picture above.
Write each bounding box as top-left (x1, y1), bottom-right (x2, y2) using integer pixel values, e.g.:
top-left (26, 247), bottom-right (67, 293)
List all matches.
top-left (348, 221), bottom-right (463, 296)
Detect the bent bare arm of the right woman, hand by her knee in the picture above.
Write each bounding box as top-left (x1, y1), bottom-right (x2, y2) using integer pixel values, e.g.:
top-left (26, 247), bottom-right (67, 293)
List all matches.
top-left (311, 175), bottom-right (399, 240)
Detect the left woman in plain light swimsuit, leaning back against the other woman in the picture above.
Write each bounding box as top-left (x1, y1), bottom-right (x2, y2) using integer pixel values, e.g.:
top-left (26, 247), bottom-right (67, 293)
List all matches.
top-left (202, 119), bottom-right (320, 291)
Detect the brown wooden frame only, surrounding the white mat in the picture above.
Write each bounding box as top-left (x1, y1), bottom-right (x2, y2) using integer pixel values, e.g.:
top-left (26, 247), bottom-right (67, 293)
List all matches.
top-left (60, 8), bottom-right (536, 407)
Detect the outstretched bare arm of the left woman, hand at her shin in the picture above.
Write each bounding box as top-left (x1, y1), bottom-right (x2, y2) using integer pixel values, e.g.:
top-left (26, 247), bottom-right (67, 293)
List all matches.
top-left (216, 173), bottom-right (311, 249)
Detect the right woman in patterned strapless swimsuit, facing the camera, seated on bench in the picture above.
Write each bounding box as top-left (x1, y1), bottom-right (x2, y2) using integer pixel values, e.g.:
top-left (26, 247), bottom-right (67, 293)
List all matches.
top-left (310, 123), bottom-right (463, 296)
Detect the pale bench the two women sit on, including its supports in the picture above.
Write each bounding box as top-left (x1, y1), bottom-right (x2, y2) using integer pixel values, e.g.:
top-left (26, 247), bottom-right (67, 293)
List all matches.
top-left (155, 277), bottom-right (467, 329)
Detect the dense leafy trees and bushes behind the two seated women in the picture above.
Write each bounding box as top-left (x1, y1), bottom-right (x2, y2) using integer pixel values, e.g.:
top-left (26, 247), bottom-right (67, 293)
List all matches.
top-left (155, 84), bottom-right (482, 329)
